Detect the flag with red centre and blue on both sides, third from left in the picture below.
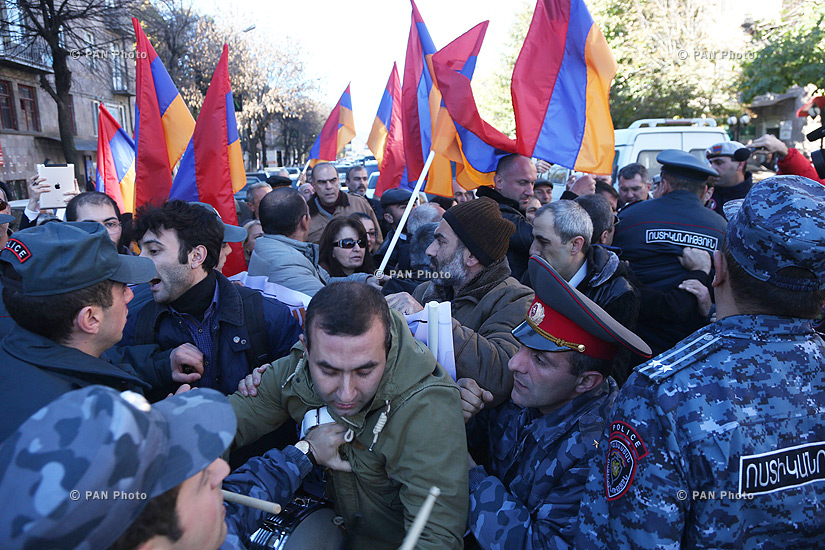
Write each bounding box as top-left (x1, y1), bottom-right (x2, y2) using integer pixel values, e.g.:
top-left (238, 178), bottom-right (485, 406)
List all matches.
top-left (169, 44), bottom-right (246, 275)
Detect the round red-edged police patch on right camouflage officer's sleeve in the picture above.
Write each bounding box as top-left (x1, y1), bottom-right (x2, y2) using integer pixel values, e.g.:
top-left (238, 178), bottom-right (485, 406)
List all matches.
top-left (604, 421), bottom-right (648, 500)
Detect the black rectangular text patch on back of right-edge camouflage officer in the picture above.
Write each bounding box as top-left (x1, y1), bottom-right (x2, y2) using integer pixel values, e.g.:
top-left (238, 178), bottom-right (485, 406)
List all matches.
top-left (739, 442), bottom-right (825, 495)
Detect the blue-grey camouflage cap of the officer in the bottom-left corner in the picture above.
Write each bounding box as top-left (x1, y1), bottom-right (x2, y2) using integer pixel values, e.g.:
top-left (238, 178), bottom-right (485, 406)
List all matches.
top-left (0, 386), bottom-right (235, 550)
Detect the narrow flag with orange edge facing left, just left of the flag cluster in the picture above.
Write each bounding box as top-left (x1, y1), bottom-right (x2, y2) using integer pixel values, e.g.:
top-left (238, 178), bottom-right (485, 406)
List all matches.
top-left (367, 63), bottom-right (404, 197)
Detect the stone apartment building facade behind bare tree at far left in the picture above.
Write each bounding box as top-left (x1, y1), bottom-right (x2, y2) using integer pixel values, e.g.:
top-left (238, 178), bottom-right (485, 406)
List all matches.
top-left (0, 0), bottom-right (135, 199)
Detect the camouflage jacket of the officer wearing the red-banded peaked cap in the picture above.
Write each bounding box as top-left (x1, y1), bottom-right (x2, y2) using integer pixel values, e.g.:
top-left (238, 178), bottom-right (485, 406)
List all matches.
top-left (468, 378), bottom-right (618, 549)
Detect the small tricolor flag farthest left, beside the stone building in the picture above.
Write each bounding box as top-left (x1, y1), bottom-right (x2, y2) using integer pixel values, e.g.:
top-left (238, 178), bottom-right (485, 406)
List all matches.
top-left (95, 103), bottom-right (135, 213)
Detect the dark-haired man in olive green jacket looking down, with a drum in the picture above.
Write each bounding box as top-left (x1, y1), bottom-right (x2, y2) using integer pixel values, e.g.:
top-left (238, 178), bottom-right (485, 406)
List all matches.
top-left (229, 282), bottom-right (469, 549)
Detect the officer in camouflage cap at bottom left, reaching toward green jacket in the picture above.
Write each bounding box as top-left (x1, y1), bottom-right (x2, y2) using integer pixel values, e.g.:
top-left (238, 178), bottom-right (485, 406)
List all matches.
top-left (0, 386), bottom-right (350, 550)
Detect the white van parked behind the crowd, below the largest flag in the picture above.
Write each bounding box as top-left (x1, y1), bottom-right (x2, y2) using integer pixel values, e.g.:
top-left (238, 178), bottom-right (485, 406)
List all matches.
top-left (613, 118), bottom-right (730, 182)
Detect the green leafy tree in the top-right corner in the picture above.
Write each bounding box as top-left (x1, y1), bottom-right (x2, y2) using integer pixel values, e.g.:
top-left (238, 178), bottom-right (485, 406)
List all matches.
top-left (741, 0), bottom-right (825, 102)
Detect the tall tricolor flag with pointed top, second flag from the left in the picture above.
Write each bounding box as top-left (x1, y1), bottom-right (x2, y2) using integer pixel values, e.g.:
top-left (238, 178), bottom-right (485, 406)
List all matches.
top-left (132, 18), bottom-right (195, 206)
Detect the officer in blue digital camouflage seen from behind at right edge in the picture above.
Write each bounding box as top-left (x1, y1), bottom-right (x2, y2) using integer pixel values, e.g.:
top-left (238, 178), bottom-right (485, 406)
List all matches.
top-left (576, 176), bottom-right (825, 549)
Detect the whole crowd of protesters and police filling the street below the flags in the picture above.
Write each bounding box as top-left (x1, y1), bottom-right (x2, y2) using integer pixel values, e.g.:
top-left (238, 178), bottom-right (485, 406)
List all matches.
top-left (0, 137), bottom-right (825, 550)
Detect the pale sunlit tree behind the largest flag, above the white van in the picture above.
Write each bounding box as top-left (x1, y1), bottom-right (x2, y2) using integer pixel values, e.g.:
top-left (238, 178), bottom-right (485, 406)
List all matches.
top-left (474, 0), bottom-right (746, 136)
